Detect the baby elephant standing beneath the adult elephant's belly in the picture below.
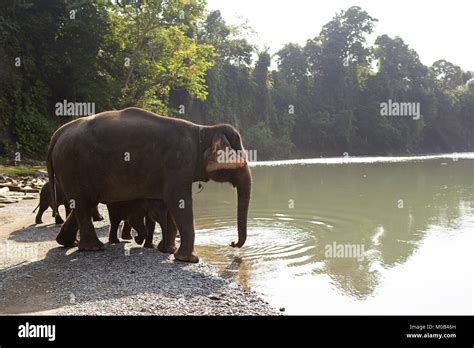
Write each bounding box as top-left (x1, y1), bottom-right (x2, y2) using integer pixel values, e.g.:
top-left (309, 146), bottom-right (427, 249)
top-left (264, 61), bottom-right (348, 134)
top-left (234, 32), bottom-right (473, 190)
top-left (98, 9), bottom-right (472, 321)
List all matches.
top-left (107, 199), bottom-right (168, 248)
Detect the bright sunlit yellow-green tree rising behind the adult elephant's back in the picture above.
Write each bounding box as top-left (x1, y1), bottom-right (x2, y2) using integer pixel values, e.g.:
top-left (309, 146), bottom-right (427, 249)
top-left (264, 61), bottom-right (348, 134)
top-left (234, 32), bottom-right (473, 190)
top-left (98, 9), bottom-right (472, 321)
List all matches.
top-left (109, 0), bottom-right (214, 114)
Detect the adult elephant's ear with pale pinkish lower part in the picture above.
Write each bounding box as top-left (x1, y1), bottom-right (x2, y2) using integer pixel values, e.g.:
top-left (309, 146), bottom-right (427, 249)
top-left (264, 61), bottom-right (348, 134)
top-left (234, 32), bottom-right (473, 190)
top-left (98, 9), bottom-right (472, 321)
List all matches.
top-left (204, 133), bottom-right (247, 173)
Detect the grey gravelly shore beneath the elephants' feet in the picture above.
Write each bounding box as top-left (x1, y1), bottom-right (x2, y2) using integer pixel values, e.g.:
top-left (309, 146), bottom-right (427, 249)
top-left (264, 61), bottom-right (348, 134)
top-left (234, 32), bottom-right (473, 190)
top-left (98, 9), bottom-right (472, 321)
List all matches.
top-left (0, 199), bottom-right (278, 315)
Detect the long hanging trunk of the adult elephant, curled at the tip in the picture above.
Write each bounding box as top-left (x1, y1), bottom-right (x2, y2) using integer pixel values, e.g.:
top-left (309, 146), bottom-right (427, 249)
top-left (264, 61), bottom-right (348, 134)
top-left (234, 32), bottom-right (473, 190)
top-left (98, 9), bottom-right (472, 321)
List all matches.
top-left (231, 167), bottom-right (252, 248)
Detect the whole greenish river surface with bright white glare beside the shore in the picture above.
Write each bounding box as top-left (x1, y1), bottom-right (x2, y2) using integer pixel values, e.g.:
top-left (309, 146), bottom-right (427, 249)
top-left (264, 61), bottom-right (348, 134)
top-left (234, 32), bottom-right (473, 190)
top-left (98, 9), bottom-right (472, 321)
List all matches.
top-left (194, 153), bottom-right (474, 314)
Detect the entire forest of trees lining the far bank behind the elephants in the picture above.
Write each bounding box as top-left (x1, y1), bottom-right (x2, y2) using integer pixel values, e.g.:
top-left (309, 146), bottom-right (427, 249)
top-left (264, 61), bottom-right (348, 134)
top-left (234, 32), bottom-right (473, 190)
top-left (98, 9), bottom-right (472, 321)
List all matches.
top-left (0, 0), bottom-right (474, 160)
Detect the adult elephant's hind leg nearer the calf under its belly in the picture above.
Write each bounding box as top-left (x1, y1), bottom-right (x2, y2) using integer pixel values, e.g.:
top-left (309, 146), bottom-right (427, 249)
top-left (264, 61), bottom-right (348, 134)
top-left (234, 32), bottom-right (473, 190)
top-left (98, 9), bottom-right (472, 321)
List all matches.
top-left (74, 201), bottom-right (104, 251)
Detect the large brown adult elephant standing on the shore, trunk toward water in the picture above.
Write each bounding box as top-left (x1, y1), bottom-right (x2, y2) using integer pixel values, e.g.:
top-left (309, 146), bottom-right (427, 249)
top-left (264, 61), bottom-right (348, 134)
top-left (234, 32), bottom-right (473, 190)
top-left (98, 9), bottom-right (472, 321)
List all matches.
top-left (47, 108), bottom-right (251, 262)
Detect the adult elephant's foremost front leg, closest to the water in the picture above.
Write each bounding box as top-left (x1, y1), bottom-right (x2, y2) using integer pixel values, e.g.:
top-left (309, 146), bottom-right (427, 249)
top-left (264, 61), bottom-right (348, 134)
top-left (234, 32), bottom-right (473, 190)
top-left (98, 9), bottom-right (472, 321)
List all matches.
top-left (165, 192), bottom-right (199, 263)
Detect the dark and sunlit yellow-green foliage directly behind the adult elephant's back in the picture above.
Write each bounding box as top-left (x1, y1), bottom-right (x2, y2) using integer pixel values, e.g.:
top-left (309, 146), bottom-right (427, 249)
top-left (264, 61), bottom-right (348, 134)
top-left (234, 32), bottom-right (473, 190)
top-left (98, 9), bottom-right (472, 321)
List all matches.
top-left (0, 0), bottom-right (214, 157)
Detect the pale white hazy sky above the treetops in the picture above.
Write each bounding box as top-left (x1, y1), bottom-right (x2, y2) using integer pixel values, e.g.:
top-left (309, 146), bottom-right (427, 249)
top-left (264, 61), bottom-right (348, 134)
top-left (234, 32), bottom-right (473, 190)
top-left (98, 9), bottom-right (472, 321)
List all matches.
top-left (208, 0), bottom-right (474, 71)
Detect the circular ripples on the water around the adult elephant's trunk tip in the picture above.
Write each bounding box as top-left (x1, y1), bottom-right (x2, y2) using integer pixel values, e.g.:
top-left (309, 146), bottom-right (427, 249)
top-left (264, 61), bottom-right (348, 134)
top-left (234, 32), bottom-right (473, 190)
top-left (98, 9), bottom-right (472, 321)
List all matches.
top-left (196, 212), bottom-right (332, 283)
